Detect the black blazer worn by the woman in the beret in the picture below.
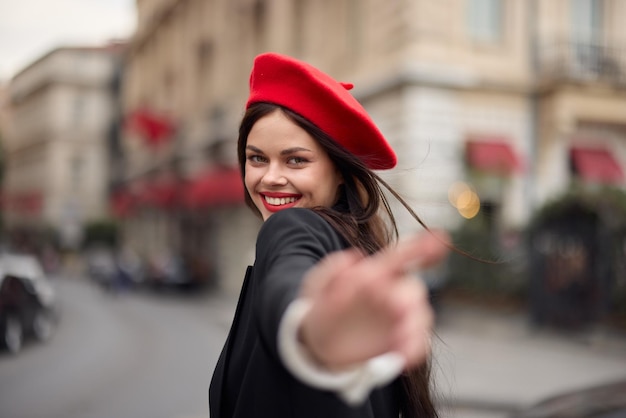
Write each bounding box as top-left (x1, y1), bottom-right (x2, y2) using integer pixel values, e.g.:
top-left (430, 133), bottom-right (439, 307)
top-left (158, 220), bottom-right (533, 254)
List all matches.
top-left (209, 208), bottom-right (401, 418)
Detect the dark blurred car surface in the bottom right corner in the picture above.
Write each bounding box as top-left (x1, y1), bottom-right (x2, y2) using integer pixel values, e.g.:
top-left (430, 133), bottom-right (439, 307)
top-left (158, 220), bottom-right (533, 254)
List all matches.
top-left (511, 380), bottom-right (626, 418)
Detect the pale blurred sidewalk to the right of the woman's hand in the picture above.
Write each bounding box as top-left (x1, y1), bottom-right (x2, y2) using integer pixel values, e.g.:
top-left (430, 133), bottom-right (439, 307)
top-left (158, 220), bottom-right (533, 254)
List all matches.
top-left (433, 304), bottom-right (626, 418)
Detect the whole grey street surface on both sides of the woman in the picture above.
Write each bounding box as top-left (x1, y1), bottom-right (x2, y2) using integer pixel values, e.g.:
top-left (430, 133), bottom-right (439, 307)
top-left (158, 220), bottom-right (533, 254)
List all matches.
top-left (0, 278), bottom-right (626, 418)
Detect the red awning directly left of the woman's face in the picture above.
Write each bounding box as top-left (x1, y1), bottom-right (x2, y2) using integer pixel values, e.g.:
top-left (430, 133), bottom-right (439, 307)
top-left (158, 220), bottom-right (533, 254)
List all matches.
top-left (182, 168), bottom-right (244, 209)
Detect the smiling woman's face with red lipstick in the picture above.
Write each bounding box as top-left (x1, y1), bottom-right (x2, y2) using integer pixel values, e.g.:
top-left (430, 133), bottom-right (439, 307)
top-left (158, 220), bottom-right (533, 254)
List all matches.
top-left (244, 110), bottom-right (343, 221)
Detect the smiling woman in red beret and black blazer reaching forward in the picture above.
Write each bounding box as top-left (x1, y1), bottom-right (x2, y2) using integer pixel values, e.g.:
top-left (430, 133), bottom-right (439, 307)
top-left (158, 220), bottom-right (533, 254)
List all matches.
top-left (209, 53), bottom-right (445, 418)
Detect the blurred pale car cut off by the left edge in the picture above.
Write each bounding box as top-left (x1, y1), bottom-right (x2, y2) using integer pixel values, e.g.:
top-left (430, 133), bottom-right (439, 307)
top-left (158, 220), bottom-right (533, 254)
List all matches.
top-left (0, 254), bottom-right (57, 354)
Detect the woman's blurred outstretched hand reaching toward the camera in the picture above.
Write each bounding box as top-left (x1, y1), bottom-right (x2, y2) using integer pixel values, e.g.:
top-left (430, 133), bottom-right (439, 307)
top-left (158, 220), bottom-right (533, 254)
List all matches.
top-left (299, 232), bottom-right (448, 370)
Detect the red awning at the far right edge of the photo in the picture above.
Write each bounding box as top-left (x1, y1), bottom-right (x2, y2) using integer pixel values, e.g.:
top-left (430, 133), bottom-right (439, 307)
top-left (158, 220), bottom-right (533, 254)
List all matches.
top-left (570, 147), bottom-right (624, 184)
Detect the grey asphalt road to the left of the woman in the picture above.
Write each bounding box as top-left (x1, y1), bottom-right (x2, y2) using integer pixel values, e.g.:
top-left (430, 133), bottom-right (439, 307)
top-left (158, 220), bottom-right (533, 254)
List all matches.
top-left (0, 278), bottom-right (234, 418)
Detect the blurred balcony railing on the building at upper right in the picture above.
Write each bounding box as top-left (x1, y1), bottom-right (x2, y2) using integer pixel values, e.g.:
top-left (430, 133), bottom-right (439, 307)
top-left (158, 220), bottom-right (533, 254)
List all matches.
top-left (538, 41), bottom-right (626, 87)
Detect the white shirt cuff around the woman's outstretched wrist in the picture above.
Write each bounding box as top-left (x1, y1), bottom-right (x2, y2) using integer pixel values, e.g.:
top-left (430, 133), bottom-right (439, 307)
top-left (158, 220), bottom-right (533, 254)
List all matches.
top-left (278, 299), bottom-right (404, 405)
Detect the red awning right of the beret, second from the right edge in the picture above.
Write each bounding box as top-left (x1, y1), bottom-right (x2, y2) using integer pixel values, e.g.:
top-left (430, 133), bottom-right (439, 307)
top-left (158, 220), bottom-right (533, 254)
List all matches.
top-left (465, 139), bottom-right (523, 175)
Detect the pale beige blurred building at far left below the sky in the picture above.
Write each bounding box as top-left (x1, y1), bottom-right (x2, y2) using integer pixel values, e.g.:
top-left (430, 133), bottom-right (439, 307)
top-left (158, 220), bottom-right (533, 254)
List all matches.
top-left (2, 43), bottom-right (122, 249)
